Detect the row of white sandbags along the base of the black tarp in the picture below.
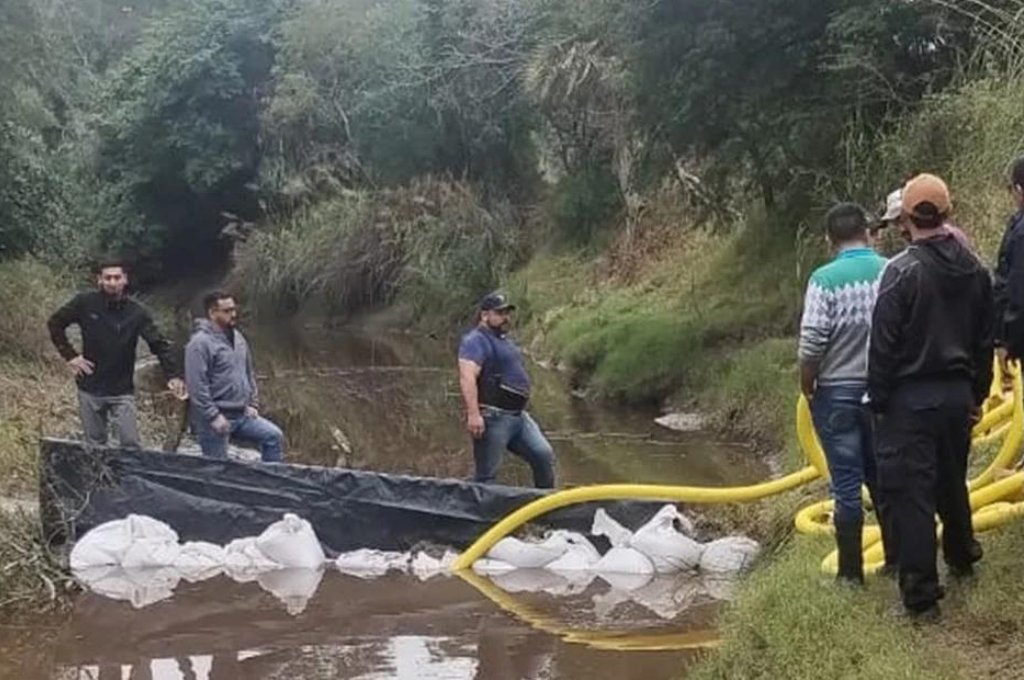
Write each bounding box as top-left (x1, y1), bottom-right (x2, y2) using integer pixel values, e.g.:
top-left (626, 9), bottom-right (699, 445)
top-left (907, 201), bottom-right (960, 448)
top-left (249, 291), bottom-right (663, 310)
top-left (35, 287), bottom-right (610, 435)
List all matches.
top-left (71, 505), bottom-right (760, 613)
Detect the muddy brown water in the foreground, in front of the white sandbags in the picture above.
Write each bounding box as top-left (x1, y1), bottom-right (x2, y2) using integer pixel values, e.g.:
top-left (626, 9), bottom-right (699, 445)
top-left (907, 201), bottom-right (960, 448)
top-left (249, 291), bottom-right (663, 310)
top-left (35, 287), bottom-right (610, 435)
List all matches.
top-left (44, 572), bottom-right (714, 680)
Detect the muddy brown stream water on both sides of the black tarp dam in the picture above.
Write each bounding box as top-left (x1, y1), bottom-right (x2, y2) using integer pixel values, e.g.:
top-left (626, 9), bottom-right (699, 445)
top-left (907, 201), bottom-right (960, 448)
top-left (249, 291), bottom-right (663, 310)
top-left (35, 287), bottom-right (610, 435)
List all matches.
top-left (0, 327), bottom-right (766, 680)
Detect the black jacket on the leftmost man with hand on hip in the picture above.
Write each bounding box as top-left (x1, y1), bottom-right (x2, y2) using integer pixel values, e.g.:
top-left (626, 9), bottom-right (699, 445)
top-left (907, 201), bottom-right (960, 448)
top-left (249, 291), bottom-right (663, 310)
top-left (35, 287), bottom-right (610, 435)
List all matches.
top-left (47, 291), bottom-right (181, 396)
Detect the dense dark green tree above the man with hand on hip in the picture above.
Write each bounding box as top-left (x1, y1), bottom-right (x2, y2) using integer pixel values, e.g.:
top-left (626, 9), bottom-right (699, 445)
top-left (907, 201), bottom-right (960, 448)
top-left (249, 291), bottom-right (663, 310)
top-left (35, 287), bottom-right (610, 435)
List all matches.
top-left (95, 0), bottom-right (279, 273)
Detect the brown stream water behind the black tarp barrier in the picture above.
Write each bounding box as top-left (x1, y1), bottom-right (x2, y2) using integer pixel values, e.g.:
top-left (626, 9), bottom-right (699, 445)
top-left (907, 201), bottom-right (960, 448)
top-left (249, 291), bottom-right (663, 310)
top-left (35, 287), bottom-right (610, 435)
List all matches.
top-left (252, 325), bottom-right (766, 485)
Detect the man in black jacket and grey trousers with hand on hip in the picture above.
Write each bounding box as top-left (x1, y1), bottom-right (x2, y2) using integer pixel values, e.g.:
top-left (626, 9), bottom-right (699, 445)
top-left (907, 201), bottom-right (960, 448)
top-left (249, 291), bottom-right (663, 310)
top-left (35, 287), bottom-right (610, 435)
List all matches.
top-left (48, 262), bottom-right (185, 449)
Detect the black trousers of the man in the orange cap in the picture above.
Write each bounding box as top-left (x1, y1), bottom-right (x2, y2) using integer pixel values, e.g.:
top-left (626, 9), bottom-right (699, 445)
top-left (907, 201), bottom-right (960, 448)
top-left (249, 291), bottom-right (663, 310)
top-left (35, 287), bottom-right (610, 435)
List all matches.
top-left (877, 380), bottom-right (975, 611)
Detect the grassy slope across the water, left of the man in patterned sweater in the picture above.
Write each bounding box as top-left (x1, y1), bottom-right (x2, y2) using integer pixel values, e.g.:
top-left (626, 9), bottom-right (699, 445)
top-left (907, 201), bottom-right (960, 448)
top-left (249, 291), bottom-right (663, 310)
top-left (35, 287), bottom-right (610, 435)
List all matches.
top-left (508, 218), bottom-right (800, 456)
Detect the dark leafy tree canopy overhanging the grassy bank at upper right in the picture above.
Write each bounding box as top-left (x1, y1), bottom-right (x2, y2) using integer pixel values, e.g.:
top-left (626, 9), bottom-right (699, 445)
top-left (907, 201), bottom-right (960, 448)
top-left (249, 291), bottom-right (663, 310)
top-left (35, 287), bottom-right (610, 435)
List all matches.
top-left (634, 0), bottom-right (969, 208)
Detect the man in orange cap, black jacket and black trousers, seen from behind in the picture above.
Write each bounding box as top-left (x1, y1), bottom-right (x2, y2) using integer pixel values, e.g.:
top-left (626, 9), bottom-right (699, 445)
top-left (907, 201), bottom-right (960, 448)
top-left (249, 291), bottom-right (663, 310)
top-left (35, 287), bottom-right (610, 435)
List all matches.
top-left (867, 175), bottom-right (994, 615)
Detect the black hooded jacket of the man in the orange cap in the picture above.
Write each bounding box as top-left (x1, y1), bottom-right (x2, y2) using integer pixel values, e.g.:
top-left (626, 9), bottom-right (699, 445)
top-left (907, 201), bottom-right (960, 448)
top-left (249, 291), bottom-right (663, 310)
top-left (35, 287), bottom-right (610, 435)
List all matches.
top-left (867, 236), bottom-right (995, 412)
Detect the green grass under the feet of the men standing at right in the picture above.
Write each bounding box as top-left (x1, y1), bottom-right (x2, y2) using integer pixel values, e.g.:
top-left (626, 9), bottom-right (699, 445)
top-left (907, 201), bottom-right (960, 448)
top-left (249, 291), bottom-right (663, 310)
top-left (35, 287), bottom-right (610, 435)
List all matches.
top-left (686, 522), bottom-right (1024, 680)
